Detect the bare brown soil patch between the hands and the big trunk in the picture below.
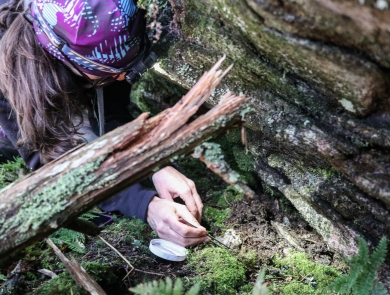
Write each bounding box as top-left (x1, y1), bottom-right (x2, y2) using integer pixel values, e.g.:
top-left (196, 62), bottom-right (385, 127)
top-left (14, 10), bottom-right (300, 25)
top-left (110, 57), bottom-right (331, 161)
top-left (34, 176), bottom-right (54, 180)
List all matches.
top-left (227, 194), bottom-right (340, 266)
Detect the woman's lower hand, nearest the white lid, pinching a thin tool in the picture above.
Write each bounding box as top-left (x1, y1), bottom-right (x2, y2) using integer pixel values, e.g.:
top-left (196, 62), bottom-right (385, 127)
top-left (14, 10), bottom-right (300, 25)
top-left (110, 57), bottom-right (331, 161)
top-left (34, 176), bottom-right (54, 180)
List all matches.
top-left (146, 197), bottom-right (209, 247)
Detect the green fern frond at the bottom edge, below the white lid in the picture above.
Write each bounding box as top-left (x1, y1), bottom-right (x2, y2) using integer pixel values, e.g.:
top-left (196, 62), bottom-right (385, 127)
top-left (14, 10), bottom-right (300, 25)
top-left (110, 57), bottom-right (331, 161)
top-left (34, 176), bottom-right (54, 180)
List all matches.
top-left (130, 277), bottom-right (200, 295)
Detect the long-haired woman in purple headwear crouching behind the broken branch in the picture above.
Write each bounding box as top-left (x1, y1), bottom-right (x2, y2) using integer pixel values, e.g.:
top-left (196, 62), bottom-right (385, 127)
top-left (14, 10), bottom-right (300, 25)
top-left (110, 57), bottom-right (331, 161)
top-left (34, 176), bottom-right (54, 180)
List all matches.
top-left (0, 0), bottom-right (208, 246)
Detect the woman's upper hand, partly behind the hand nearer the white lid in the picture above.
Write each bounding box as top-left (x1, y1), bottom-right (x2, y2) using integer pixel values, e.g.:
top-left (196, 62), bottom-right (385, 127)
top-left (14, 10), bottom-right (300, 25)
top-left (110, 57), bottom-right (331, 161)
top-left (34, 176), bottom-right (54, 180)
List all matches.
top-left (152, 166), bottom-right (203, 221)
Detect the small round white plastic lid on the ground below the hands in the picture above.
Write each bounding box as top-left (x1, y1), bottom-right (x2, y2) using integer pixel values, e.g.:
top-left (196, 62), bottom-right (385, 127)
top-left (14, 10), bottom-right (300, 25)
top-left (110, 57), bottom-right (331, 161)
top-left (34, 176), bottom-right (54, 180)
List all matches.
top-left (149, 239), bottom-right (188, 261)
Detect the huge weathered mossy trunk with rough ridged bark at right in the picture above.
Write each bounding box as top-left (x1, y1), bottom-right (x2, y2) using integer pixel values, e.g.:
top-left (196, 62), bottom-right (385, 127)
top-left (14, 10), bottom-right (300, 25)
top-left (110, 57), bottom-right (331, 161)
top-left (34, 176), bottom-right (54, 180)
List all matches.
top-left (149, 0), bottom-right (390, 270)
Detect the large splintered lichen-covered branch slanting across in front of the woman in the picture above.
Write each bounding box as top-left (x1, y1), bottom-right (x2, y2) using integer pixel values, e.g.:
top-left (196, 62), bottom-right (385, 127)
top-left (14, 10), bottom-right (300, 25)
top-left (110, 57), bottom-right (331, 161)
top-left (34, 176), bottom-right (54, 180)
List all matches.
top-left (0, 55), bottom-right (247, 258)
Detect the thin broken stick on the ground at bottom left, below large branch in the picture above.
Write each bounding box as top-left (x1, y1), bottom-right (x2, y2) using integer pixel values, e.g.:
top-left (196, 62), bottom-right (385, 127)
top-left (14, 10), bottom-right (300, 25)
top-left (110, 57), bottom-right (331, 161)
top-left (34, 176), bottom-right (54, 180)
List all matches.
top-left (46, 239), bottom-right (106, 295)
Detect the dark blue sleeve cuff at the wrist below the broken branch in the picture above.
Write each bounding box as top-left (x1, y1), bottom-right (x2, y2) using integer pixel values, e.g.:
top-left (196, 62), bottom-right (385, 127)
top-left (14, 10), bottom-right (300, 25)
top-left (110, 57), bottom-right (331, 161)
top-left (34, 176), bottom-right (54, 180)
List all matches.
top-left (98, 183), bottom-right (157, 222)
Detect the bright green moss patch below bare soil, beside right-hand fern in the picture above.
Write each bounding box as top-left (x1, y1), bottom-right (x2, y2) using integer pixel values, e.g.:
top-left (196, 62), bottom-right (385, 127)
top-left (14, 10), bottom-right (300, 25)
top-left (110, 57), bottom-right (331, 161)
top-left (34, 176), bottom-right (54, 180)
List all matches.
top-left (267, 253), bottom-right (341, 295)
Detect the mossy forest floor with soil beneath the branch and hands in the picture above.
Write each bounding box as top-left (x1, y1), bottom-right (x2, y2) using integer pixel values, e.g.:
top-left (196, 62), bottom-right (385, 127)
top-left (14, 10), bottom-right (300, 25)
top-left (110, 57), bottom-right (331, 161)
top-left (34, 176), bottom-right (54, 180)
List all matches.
top-left (0, 140), bottom-right (345, 295)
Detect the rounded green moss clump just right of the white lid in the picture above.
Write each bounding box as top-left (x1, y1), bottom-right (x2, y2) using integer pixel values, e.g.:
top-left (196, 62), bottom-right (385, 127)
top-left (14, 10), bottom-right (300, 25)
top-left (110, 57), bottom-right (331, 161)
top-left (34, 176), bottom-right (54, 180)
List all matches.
top-left (189, 247), bottom-right (246, 295)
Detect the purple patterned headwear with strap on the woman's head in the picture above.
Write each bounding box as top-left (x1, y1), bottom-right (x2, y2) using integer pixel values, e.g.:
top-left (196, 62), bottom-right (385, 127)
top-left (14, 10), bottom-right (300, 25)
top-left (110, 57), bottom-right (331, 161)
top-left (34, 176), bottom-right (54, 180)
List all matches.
top-left (31, 0), bottom-right (145, 76)
